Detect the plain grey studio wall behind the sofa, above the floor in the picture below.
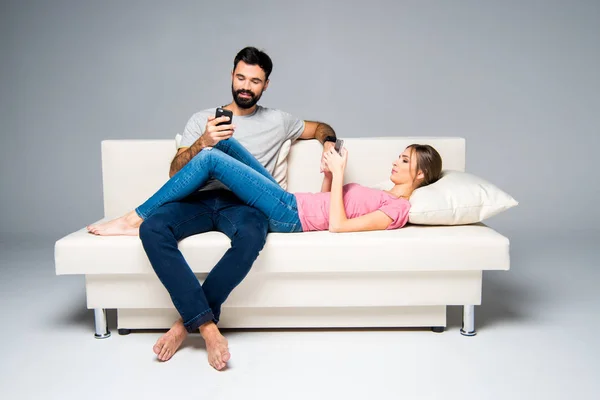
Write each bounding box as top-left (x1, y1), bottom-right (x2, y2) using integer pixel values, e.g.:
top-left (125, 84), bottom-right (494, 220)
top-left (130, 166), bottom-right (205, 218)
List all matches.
top-left (0, 0), bottom-right (600, 238)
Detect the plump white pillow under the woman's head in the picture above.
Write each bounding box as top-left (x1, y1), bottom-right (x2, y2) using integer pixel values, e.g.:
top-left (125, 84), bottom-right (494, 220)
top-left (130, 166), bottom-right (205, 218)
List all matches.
top-left (408, 170), bottom-right (519, 225)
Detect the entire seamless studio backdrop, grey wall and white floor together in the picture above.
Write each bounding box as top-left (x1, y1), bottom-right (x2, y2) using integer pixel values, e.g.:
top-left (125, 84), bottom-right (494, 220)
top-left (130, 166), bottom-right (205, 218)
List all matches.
top-left (0, 0), bottom-right (600, 400)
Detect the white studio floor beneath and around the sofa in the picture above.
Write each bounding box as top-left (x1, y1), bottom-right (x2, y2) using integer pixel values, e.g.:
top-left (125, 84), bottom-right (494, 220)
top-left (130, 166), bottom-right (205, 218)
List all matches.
top-left (0, 232), bottom-right (600, 400)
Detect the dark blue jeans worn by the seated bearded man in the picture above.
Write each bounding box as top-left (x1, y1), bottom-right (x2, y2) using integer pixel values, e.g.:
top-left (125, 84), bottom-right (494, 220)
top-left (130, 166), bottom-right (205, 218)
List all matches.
top-left (140, 190), bottom-right (268, 332)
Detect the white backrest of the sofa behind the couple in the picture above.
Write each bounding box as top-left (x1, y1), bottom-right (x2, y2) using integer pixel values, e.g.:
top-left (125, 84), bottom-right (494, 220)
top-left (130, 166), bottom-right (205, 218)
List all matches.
top-left (102, 137), bottom-right (465, 218)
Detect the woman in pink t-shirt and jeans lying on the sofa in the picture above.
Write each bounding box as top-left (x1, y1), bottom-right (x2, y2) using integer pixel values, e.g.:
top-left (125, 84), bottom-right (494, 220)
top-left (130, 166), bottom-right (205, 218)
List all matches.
top-left (87, 138), bottom-right (442, 235)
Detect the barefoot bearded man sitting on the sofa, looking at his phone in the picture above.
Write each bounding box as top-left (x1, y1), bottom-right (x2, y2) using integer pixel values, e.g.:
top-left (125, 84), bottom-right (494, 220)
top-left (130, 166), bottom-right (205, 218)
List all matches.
top-left (139, 47), bottom-right (335, 370)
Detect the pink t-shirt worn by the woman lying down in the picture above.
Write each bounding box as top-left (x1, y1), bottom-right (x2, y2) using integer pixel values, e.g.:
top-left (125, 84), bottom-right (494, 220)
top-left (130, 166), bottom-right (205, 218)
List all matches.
top-left (294, 183), bottom-right (410, 232)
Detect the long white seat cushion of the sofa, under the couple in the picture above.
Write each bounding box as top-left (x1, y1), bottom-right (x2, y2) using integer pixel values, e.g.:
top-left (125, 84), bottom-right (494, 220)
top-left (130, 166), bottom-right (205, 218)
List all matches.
top-left (55, 223), bottom-right (509, 274)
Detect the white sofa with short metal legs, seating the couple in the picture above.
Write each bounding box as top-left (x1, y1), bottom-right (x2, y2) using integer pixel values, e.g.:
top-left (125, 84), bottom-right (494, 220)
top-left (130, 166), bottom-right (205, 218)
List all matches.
top-left (55, 137), bottom-right (509, 338)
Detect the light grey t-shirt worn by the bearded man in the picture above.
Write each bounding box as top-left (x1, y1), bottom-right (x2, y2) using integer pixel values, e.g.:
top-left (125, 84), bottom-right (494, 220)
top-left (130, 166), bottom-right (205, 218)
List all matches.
top-left (179, 106), bottom-right (304, 190)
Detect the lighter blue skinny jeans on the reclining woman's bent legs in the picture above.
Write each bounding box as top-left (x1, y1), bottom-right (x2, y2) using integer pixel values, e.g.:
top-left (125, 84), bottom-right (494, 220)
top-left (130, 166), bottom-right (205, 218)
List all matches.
top-left (135, 138), bottom-right (302, 232)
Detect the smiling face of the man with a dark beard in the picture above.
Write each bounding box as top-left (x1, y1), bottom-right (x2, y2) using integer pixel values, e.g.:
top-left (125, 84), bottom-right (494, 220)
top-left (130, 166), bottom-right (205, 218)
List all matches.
top-left (231, 61), bottom-right (269, 109)
